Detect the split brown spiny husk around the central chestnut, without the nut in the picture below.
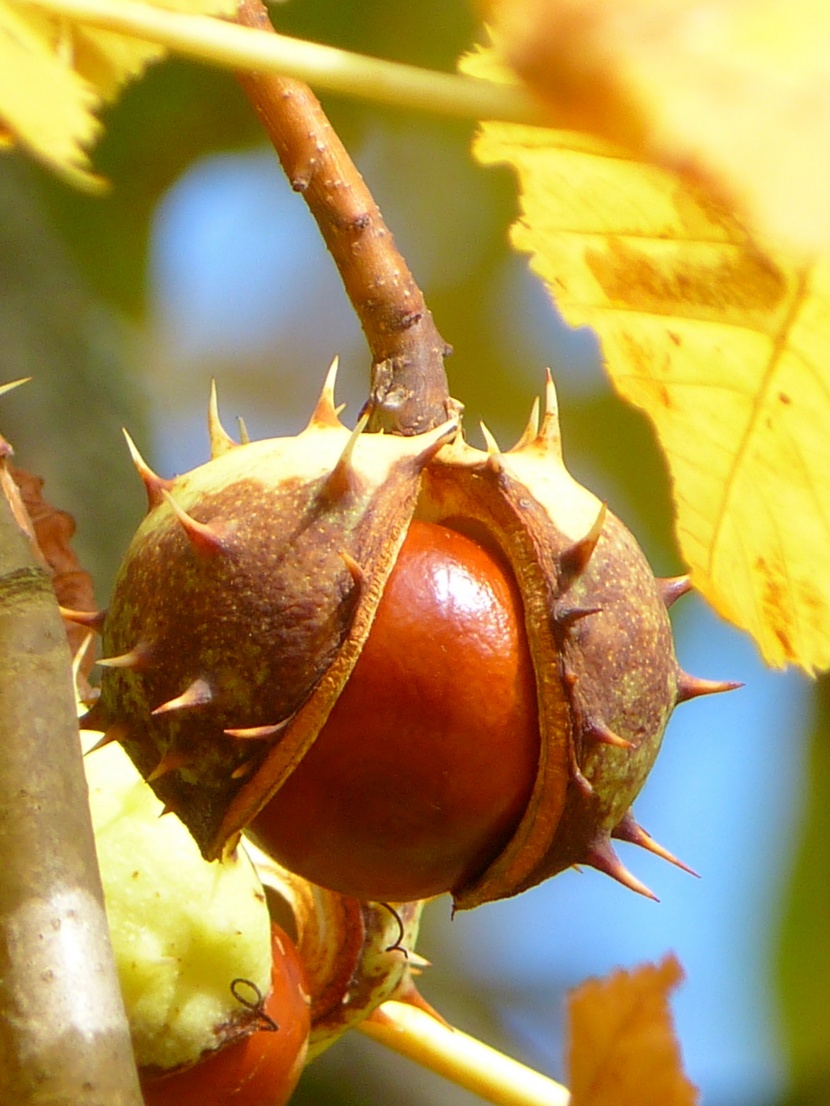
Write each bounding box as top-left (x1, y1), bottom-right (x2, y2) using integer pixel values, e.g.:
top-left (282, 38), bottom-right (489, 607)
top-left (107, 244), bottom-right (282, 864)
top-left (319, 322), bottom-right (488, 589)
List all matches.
top-left (86, 362), bottom-right (732, 908)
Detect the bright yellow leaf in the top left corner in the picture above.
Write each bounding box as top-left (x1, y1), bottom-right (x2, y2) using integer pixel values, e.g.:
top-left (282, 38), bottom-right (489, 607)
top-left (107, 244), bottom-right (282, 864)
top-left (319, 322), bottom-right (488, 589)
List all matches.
top-left (0, 0), bottom-right (236, 187)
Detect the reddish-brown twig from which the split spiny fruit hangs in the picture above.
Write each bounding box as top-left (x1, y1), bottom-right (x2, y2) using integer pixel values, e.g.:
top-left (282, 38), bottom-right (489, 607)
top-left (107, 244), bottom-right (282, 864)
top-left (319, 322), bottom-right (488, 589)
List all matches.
top-left (237, 0), bottom-right (455, 435)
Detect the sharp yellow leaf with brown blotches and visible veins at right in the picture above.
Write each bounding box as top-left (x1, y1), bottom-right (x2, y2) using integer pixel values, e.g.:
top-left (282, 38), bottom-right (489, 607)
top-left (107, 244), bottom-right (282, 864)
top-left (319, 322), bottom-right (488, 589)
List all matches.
top-left (465, 45), bottom-right (830, 671)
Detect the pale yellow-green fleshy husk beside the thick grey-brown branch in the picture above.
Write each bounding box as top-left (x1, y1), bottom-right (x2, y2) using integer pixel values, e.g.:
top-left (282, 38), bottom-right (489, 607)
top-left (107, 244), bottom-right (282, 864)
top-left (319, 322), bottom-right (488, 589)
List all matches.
top-left (84, 733), bottom-right (271, 1068)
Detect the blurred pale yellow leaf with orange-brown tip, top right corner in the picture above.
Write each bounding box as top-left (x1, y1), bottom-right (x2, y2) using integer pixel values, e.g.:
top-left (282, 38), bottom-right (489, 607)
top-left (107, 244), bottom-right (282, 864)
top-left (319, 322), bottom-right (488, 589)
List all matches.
top-left (490, 0), bottom-right (830, 252)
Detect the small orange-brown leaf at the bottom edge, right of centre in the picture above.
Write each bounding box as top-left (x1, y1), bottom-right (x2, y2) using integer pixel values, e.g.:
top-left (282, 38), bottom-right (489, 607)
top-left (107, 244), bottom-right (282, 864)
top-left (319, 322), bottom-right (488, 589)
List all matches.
top-left (568, 957), bottom-right (698, 1106)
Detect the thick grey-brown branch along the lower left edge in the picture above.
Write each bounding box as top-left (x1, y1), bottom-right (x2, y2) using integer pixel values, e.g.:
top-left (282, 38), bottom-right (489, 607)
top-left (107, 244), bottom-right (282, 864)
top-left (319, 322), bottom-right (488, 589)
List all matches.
top-left (0, 453), bottom-right (142, 1106)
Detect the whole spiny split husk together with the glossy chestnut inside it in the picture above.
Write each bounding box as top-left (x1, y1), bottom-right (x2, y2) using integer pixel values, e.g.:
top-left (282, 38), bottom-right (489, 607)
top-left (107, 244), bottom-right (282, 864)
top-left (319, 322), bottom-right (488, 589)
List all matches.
top-left (87, 365), bottom-right (738, 909)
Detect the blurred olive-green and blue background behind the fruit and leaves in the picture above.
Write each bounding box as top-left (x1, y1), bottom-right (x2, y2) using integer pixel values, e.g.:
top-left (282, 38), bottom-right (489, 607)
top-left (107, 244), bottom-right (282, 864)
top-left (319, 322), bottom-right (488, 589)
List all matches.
top-left (0, 0), bottom-right (830, 1106)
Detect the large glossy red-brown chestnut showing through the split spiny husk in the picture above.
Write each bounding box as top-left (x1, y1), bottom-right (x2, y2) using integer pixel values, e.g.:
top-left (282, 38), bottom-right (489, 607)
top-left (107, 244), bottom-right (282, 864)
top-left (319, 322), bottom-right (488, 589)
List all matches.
top-left (250, 520), bottom-right (539, 901)
